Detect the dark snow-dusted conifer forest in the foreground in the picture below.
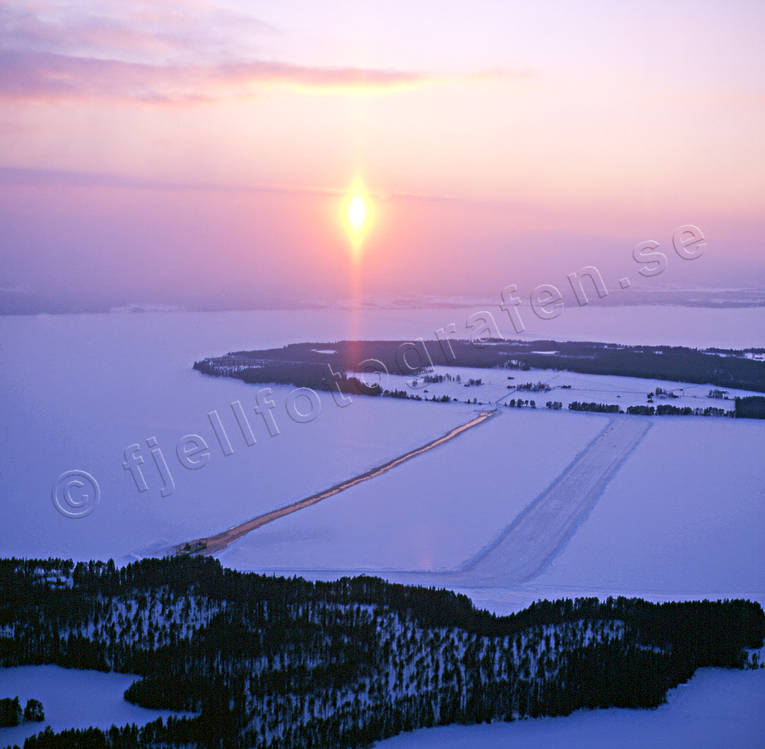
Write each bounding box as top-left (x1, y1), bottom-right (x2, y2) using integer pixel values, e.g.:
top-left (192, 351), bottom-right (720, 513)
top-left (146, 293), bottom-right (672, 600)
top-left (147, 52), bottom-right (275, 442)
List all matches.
top-left (0, 556), bottom-right (765, 749)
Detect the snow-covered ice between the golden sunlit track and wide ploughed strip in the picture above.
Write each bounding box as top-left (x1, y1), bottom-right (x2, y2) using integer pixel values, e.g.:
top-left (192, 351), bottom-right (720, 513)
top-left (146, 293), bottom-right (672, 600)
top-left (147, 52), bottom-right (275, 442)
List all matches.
top-left (220, 404), bottom-right (608, 571)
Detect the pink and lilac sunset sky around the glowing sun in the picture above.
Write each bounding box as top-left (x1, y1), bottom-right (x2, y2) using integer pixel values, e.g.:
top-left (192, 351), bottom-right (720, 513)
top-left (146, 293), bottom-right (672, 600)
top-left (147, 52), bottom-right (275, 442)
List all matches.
top-left (0, 0), bottom-right (765, 306)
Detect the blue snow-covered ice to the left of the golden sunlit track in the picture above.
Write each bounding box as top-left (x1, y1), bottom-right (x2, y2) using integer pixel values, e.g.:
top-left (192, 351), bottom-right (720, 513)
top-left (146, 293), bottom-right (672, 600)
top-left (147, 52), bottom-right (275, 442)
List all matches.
top-left (0, 314), bottom-right (473, 560)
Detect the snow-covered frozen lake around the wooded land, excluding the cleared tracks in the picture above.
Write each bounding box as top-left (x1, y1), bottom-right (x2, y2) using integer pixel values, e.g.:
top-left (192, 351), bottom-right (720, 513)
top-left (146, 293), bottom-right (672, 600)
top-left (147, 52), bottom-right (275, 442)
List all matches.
top-left (0, 307), bottom-right (765, 611)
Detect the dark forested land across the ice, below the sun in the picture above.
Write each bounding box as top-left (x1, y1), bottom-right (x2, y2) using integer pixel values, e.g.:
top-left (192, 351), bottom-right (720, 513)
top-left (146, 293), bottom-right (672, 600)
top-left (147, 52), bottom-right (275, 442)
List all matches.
top-left (194, 339), bottom-right (765, 406)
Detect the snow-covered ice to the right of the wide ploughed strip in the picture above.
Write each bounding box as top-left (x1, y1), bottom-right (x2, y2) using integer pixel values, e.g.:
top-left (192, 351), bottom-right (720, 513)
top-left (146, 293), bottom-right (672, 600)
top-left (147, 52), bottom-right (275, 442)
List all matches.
top-left (534, 416), bottom-right (765, 598)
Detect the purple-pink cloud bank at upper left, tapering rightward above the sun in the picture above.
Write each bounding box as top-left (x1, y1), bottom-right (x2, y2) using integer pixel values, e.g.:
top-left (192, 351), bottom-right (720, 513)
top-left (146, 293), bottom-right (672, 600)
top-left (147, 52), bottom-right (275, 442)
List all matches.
top-left (0, 0), bottom-right (504, 103)
